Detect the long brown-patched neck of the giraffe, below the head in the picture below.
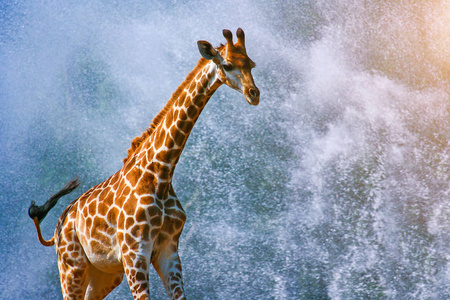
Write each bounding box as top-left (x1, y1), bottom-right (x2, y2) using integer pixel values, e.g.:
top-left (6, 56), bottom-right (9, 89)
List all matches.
top-left (130, 58), bottom-right (222, 199)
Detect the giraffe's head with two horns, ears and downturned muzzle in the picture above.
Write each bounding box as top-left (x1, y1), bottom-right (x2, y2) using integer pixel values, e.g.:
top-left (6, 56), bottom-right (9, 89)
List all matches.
top-left (197, 28), bottom-right (259, 105)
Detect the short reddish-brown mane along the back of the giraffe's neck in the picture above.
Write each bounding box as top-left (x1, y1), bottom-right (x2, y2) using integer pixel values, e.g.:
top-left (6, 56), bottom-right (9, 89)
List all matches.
top-left (123, 56), bottom-right (213, 164)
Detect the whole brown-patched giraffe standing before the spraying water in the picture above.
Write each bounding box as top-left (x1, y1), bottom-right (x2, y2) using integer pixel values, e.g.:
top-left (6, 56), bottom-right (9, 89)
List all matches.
top-left (29, 28), bottom-right (259, 299)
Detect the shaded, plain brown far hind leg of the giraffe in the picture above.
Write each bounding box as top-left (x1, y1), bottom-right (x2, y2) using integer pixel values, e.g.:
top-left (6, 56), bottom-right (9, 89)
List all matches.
top-left (85, 265), bottom-right (123, 300)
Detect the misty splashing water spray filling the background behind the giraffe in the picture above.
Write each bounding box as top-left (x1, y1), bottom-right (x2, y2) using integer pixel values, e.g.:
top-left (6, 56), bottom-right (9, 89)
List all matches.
top-left (0, 0), bottom-right (450, 299)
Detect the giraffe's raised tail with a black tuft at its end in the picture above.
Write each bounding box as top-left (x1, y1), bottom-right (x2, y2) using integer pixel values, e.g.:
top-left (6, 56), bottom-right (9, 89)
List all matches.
top-left (28, 177), bottom-right (80, 247)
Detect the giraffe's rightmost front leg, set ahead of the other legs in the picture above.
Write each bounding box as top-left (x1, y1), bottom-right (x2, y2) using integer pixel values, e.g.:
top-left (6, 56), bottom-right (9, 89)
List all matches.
top-left (153, 244), bottom-right (186, 300)
